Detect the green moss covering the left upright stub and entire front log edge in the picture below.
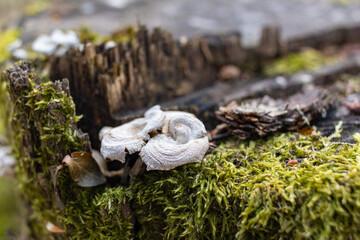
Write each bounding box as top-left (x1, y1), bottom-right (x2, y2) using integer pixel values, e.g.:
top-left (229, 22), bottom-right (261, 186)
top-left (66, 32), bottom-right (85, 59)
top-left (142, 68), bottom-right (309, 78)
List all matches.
top-left (2, 62), bottom-right (360, 239)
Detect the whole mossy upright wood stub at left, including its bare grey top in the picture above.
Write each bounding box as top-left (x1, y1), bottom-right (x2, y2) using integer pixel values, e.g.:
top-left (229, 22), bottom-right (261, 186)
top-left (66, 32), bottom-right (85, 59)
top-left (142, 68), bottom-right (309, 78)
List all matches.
top-left (2, 61), bottom-right (90, 239)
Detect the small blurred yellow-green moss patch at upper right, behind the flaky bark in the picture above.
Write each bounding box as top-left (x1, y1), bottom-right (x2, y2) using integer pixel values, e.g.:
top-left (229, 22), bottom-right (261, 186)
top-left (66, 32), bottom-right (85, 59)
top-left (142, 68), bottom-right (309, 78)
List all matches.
top-left (264, 49), bottom-right (335, 76)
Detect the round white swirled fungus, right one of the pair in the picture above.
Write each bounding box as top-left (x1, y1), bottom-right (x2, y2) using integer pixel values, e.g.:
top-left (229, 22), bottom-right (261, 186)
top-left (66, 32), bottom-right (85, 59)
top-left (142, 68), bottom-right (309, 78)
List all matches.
top-left (140, 111), bottom-right (209, 171)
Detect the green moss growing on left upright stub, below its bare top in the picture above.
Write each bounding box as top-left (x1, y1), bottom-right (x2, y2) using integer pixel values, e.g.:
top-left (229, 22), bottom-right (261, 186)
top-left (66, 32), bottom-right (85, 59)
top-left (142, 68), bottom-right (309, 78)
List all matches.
top-left (6, 68), bottom-right (81, 238)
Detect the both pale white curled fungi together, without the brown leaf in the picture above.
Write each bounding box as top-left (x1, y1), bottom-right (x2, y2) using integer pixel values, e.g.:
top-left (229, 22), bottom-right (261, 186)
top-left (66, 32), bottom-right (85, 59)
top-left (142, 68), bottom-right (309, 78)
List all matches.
top-left (99, 105), bottom-right (209, 171)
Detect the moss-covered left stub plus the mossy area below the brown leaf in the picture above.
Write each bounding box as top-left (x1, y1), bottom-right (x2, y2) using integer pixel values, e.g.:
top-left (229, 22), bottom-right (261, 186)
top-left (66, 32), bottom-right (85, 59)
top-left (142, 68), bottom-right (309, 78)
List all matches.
top-left (4, 62), bottom-right (133, 239)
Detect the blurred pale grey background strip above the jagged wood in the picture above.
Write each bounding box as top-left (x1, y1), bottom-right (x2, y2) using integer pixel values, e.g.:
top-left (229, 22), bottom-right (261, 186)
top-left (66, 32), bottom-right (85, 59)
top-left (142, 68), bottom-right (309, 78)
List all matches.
top-left (0, 0), bottom-right (360, 44)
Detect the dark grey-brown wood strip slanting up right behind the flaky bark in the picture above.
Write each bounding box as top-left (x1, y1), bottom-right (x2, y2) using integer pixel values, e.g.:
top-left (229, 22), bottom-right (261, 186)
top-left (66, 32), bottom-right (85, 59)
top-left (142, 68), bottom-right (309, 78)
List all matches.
top-left (158, 54), bottom-right (360, 129)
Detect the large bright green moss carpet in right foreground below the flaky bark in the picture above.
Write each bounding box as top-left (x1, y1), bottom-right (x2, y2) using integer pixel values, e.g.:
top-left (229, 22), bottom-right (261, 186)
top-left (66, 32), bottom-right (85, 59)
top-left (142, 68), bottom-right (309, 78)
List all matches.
top-left (130, 124), bottom-right (360, 239)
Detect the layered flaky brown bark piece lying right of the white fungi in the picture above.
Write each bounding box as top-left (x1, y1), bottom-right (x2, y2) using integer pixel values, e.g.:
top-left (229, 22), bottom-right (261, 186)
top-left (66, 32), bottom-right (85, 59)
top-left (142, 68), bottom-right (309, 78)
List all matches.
top-left (216, 89), bottom-right (331, 140)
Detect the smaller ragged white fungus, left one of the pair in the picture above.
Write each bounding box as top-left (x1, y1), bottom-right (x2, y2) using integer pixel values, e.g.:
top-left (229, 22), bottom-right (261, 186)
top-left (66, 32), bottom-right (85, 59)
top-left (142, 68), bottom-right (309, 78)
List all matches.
top-left (99, 105), bottom-right (165, 163)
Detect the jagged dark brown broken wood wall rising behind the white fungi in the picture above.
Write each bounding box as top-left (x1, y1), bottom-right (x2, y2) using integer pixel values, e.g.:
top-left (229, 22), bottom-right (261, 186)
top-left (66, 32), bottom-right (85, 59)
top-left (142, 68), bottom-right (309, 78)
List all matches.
top-left (50, 26), bottom-right (358, 146)
